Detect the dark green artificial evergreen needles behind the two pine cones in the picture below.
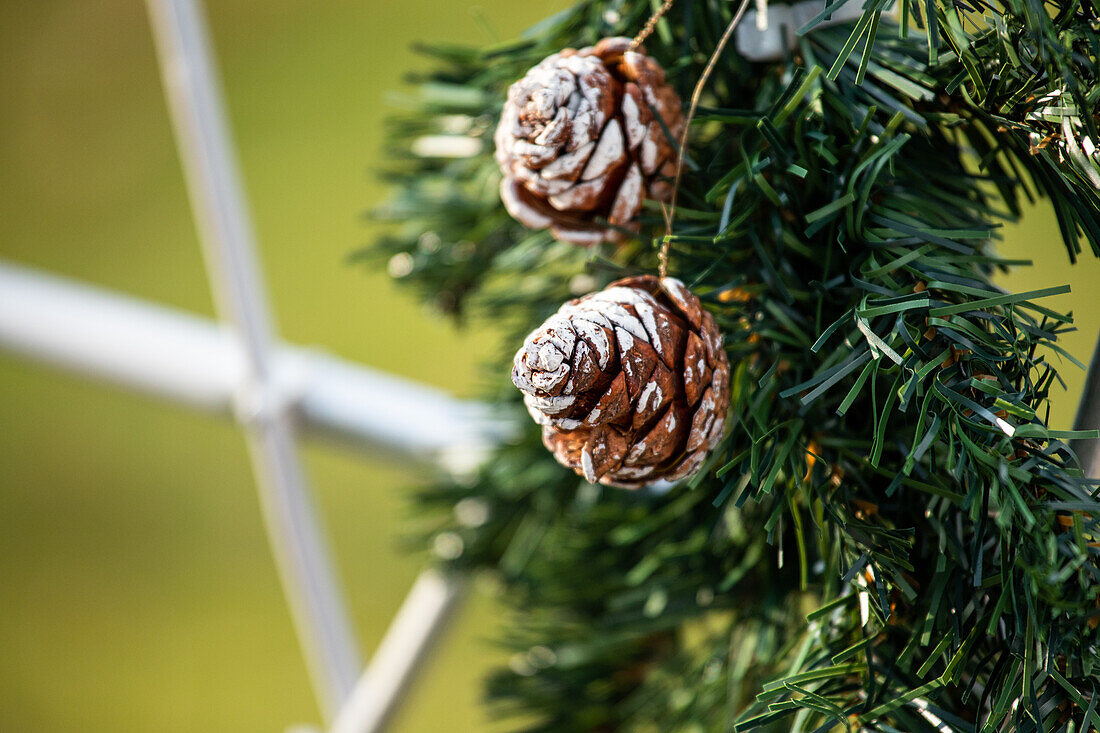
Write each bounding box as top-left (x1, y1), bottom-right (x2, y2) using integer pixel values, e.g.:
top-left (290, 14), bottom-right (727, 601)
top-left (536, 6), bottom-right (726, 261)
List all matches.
top-left (369, 0), bottom-right (1100, 733)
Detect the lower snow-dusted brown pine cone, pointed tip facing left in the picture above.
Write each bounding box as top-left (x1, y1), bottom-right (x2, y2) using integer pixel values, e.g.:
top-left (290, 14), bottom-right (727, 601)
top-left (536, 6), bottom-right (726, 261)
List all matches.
top-left (512, 275), bottom-right (729, 489)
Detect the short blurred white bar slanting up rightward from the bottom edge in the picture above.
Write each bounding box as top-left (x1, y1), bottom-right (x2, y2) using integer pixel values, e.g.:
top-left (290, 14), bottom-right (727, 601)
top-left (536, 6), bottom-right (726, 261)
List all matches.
top-left (330, 570), bottom-right (465, 733)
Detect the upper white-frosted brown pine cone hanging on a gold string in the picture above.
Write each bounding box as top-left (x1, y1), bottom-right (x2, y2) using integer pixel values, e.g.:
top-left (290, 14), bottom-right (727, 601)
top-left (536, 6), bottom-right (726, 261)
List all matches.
top-left (495, 37), bottom-right (684, 245)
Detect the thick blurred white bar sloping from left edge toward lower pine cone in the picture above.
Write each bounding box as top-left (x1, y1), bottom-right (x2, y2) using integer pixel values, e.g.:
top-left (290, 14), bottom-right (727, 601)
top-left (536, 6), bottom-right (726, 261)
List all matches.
top-left (0, 260), bottom-right (517, 460)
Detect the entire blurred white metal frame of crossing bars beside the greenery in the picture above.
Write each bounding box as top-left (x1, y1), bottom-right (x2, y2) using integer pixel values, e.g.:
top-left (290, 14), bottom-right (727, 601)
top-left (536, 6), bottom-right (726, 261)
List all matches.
top-left (0, 0), bottom-right (503, 733)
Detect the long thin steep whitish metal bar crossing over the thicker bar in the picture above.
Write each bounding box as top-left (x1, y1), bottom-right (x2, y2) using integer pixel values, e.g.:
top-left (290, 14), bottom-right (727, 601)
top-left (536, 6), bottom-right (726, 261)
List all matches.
top-left (147, 0), bottom-right (360, 720)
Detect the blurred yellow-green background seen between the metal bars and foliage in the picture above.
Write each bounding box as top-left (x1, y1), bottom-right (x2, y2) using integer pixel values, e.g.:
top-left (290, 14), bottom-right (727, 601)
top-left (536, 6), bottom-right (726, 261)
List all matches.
top-left (0, 0), bottom-right (1100, 733)
